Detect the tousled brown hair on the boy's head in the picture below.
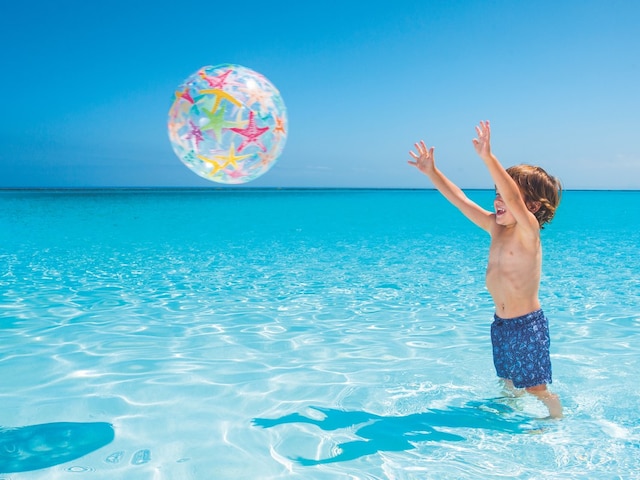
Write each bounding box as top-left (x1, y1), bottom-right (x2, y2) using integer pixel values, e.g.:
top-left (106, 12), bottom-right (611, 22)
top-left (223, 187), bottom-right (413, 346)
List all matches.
top-left (507, 165), bottom-right (562, 228)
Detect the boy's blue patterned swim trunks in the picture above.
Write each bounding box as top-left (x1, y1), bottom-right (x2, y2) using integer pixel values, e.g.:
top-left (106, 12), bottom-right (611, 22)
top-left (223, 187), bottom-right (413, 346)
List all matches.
top-left (491, 310), bottom-right (551, 388)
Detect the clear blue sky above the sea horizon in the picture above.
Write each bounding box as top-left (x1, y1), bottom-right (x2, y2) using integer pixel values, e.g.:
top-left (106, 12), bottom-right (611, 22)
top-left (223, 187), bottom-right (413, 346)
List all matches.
top-left (0, 0), bottom-right (640, 189)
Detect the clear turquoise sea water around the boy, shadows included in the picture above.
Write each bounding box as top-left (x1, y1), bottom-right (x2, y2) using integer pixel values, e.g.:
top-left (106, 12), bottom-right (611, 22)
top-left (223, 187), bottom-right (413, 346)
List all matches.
top-left (0, 190), bottom-right (640, 480)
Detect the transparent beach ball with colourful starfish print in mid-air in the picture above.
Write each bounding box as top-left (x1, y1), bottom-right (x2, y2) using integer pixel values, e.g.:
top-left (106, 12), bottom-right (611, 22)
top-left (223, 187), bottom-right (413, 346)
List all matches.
top-left (168, 65), bottom-right (287, 184)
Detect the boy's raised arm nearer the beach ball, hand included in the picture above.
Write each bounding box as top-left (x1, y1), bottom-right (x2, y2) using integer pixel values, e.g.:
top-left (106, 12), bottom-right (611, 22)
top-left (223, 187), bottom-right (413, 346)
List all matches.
top-left (408, 141), bottom-right (493, 231)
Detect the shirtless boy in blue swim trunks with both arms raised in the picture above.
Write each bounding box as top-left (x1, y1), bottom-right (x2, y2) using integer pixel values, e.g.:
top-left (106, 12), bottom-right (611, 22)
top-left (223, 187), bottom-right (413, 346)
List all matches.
top-left (409, 122), bottom-right (562, 418)
